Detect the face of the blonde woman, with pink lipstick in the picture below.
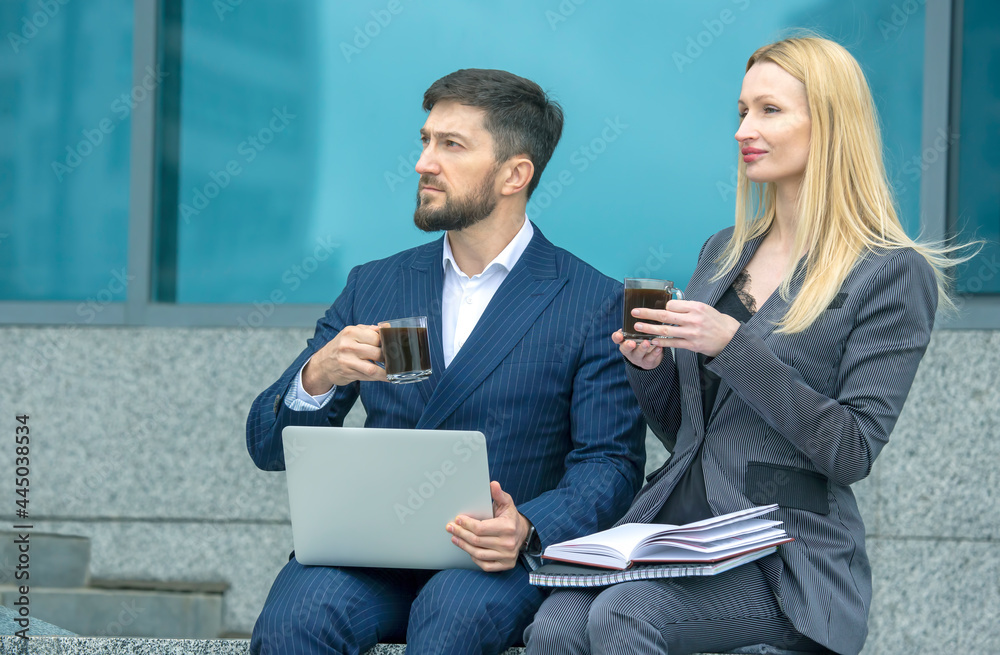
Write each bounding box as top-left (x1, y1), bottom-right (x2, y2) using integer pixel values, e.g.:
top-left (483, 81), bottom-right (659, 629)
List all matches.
top-left (736, 61), bottom-right (812, 185)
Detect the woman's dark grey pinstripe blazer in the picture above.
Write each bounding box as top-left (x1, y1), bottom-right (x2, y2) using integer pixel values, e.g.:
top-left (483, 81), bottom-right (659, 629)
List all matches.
top-left (621, 228), bottom-right (937, 654)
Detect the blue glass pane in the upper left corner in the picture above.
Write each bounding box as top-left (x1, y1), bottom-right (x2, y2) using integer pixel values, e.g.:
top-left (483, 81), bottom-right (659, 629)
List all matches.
top-left (0, 0), bottom-right (131, 302)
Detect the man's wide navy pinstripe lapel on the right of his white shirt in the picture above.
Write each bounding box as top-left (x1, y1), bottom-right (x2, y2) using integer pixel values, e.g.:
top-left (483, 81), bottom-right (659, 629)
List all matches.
top-left (417, 227), bottom-right (566, 429)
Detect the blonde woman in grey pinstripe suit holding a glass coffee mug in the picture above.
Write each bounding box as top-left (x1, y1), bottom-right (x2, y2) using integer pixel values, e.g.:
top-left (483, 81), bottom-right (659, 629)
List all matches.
top-left (525, 37), bottom-right (953, 655)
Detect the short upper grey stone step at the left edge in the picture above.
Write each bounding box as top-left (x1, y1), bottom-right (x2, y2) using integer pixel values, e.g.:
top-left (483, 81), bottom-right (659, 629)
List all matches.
top-left (0, 531), bottom-right (90, 589)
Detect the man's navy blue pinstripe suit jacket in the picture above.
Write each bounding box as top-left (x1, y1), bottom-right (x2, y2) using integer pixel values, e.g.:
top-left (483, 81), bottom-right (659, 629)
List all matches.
top-left (247, 227), bottom-right (645, 546)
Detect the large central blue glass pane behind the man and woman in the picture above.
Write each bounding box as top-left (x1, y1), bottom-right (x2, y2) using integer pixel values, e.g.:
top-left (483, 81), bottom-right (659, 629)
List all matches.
top-left (177, 0), bottom-right (924, 303)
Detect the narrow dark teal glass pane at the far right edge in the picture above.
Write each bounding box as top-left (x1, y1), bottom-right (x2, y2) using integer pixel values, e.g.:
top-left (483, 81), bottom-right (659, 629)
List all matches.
top-left (955, 0), bottom-right (1000, 294)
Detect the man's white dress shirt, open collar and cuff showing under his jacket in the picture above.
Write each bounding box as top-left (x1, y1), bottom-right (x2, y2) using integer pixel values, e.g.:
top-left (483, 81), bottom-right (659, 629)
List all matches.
top-left (285, 216), bottom-right (535, 412)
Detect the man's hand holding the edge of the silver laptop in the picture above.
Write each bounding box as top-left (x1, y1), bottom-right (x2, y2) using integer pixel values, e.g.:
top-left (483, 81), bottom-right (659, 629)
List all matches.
top-left (447, 481), bottom-right (531, 571)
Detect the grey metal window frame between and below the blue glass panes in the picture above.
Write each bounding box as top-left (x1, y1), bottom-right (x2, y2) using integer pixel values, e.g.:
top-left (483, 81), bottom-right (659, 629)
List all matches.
top-left (0, 0), bottom-right (1000, 329)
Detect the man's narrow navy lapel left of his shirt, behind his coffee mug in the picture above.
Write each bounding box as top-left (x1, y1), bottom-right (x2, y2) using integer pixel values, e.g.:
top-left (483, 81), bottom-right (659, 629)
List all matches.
top-left (393, 237), bottom-right (444, 405)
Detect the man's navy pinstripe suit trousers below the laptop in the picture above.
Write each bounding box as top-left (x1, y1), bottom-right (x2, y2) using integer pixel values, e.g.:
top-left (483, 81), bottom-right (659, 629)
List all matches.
top-left (250, 557), bottom-right (544, 655)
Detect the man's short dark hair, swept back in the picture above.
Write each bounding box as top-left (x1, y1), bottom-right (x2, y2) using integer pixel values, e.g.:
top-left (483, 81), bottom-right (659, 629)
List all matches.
top-left (424, 68), bottom-right (563, 198)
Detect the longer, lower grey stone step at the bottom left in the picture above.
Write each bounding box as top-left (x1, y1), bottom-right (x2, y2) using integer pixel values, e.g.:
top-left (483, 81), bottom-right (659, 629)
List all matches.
top-left (0, 588), bottom-right (222, 640)
